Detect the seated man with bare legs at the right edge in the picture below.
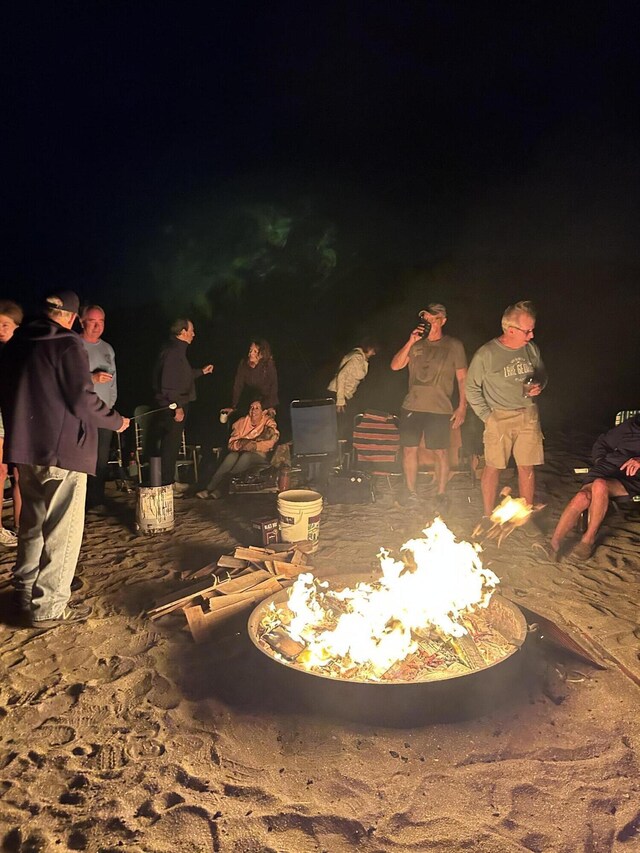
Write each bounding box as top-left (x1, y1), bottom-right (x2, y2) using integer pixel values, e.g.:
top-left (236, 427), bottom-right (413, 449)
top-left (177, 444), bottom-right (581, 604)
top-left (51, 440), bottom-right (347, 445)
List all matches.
top-left (551, 415), bottom-right (640, 560)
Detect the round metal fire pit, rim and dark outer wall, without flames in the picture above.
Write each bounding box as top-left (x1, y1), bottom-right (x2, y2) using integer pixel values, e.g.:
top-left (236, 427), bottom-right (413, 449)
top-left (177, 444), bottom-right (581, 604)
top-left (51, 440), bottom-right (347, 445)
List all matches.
top-left (248, 574), bottom-right (527, 725)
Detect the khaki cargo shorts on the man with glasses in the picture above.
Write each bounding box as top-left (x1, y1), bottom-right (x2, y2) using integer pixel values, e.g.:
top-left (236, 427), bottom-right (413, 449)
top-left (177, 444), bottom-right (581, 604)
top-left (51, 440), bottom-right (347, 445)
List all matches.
top-left (483, 406), bottom-right (544, 468)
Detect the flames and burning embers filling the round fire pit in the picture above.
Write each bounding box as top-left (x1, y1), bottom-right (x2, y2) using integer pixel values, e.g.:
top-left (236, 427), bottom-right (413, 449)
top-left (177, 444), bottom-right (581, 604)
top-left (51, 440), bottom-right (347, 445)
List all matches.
top-left (249, 519), bottom-right (526, 684)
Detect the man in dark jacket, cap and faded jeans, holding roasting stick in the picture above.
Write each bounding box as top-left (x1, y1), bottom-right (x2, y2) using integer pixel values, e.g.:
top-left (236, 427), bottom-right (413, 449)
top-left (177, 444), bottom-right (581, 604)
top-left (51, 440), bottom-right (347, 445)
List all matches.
top-left (0, 290), bottom-right (129, 628)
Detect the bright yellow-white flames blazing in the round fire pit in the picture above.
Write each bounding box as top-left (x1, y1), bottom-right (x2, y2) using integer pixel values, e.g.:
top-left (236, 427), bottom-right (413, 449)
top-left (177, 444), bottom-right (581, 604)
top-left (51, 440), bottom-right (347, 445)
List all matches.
top-left (261, 518), bottom-right (499, 681)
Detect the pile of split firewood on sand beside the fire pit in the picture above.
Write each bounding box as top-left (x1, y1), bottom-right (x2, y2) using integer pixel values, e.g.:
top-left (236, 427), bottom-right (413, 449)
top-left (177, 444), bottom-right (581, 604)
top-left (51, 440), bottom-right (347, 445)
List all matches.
top-left (147, 542), bottom-right (314, 643)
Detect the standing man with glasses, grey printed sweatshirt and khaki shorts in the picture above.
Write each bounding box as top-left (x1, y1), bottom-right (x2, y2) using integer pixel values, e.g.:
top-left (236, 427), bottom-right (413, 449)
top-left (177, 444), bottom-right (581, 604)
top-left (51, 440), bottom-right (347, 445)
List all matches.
top-left (467, 301), bottom-right (546, 515)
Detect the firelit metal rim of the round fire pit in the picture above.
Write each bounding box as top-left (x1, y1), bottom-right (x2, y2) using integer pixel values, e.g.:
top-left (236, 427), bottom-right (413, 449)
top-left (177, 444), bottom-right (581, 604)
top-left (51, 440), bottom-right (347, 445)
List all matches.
top-left (247, 574), bottom-right (527, 686)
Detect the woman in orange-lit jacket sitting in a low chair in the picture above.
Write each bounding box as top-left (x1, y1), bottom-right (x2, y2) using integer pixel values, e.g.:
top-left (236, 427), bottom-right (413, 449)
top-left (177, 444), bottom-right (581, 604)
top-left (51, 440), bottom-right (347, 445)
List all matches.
top-left (197, 400), bottom-right (280, 500)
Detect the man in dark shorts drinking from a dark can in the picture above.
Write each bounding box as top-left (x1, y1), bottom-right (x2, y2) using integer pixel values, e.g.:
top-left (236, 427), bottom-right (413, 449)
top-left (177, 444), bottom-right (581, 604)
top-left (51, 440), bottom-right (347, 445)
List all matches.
top-left (391, 302), bottom-right (467, 509)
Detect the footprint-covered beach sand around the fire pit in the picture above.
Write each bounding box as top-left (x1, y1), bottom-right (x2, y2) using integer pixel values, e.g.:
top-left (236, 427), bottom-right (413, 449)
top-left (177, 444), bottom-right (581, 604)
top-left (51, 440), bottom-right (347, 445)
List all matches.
top-left (0, 442), bottom-right (640, 853)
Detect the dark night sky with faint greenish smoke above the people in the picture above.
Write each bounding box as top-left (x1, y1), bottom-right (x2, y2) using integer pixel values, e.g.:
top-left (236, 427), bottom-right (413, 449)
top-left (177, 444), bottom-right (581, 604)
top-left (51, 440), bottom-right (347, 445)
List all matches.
top-left (2, 0), bottom-right (640, 432)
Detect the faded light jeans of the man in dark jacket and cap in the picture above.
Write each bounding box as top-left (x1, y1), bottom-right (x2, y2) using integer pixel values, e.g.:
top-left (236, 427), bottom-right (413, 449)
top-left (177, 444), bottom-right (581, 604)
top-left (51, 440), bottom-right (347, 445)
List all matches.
top-left (13, 464), bottom-right (87, 621)
